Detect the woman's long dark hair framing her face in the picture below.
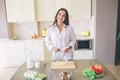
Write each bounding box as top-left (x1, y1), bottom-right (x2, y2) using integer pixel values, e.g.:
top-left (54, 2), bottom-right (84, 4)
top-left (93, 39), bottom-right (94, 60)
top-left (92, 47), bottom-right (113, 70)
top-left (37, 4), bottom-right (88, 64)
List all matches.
top-left (53, 8), bottom-right (69, 25)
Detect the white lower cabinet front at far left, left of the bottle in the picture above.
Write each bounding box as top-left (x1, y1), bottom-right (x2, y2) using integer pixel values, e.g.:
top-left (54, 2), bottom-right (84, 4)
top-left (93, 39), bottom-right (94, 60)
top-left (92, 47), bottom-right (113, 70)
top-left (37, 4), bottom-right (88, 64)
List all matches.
top-left (6, 41), bottom-right (25, 67)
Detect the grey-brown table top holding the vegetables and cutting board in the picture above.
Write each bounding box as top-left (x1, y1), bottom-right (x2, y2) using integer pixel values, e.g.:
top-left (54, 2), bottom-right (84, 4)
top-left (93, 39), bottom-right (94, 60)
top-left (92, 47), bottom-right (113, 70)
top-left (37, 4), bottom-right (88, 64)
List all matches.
top-left (11, 59), bottom-right (116, 80)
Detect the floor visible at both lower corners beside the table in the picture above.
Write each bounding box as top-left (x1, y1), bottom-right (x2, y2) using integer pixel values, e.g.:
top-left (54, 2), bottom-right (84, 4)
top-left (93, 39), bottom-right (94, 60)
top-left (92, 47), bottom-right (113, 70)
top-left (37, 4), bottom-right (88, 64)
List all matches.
top-left (0, 65), bottom-right (120, 80)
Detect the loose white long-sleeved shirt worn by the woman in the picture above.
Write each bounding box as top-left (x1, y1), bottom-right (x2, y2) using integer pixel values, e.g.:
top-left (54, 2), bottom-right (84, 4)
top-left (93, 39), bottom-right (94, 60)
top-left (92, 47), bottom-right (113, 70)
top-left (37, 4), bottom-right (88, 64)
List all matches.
top-left (45, 24), bottom-right (76, 61)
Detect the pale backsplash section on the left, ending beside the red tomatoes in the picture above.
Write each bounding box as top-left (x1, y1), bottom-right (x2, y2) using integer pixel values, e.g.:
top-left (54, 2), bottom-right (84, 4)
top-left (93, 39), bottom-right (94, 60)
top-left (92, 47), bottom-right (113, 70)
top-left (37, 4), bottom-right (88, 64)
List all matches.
top-left (8, 22), bottom-right (38, 39)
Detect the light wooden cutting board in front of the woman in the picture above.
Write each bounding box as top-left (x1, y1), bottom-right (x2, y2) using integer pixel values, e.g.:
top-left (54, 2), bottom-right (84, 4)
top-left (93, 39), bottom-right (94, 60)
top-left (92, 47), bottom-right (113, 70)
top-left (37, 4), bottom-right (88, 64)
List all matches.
top-left (51, 61), bottom-right (76, 69)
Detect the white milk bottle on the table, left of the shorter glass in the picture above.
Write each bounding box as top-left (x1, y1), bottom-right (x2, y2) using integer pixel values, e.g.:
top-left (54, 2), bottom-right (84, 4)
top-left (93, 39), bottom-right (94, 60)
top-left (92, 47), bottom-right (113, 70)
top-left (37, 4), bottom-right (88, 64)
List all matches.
top-left (26, 51), bottom-right (34, 68)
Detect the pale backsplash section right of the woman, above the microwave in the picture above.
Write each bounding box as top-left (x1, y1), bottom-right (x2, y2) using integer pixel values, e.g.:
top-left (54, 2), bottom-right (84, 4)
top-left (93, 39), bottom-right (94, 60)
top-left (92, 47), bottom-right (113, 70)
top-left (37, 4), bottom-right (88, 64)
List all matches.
top-left (70, 20), bottom-right (95, 39)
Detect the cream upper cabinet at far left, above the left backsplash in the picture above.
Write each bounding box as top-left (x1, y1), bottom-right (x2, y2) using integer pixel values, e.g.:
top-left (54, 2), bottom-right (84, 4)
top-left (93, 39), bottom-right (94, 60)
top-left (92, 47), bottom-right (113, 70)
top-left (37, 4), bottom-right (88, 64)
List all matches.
top-left (6, 0), bottom-right (35, 22)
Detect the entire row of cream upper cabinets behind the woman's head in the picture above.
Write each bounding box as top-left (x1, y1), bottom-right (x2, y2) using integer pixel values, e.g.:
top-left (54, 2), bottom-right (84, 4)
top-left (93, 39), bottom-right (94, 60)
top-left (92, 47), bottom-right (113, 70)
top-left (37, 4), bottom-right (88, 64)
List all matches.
top-left (6, 0), bottom-right (91, 22)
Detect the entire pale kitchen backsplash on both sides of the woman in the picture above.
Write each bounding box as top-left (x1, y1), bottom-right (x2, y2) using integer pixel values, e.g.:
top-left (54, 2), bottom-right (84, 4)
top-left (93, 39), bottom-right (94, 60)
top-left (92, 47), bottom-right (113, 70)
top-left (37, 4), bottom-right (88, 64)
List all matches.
top-left (8, 19), bottom-right (95, 39)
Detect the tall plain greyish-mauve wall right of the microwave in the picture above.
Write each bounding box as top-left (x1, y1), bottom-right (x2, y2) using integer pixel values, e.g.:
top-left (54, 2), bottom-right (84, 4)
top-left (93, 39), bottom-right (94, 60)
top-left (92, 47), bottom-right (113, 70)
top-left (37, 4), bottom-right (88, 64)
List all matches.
top-left (93, 0), bottom-right (118, 64)
